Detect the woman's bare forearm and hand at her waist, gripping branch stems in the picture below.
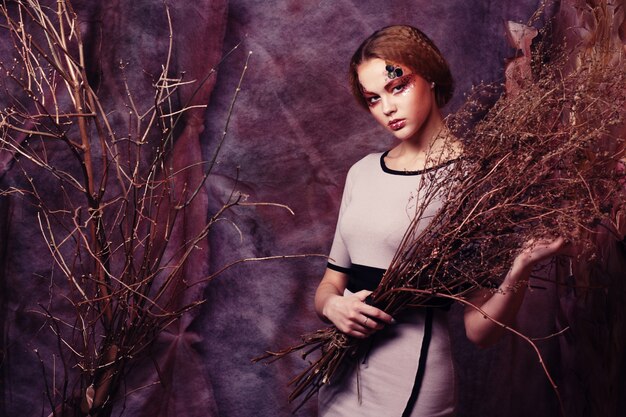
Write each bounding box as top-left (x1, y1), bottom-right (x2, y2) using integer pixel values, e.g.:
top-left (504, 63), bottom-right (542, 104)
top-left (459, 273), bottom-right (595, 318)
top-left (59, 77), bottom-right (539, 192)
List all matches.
top-left (315, 268), bottom-right (393, 338)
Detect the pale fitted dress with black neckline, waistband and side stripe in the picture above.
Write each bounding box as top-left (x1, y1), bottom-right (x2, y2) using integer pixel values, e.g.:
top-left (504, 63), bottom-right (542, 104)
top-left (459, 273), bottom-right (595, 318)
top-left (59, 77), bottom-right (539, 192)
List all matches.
top-left (318, 153), bottom-right (455, 417)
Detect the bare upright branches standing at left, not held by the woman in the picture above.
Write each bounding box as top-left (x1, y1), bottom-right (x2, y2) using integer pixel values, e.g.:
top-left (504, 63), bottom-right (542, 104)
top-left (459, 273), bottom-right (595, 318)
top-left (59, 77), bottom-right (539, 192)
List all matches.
top-left (0, 0), bottom-right (284, 416)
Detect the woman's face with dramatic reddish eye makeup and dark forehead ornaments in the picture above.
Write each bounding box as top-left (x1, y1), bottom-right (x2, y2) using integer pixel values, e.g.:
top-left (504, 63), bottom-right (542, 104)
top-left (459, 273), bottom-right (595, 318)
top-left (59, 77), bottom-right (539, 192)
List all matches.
top-left (357, 58), bottom-right (437, 141)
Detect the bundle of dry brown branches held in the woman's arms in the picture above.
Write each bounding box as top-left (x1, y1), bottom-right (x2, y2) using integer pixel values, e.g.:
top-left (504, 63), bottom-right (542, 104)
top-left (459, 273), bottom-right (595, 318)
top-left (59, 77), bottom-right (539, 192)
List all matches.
top-left (257, 3), bottom-right (626, 403)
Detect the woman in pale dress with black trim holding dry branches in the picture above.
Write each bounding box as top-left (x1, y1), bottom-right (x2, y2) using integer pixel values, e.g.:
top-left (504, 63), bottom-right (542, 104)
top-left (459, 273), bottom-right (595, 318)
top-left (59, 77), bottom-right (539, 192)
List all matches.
top-left (315, 26), bottom-right (564, 417)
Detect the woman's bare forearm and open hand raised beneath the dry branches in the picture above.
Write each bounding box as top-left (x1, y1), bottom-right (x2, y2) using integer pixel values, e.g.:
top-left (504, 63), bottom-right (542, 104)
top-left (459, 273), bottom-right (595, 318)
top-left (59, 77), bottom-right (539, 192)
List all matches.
top-left (464, 238), bottom-right (567, 347)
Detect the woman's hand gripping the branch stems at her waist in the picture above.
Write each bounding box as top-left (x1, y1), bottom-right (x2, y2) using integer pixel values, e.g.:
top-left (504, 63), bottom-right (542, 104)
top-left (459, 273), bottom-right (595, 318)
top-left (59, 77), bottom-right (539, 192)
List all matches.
top-left (322, 290), bottom-right (393, 338)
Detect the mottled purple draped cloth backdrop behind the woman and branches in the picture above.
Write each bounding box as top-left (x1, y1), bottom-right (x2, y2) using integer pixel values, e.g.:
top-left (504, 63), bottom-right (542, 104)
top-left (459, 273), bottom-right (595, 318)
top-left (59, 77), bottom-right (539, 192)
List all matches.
top-left (0, 0), bottom-right (626, 417)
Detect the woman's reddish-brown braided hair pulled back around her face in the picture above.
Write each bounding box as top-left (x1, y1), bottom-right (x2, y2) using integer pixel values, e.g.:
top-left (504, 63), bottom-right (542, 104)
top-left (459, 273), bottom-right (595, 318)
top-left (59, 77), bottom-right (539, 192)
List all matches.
top-left (349, 25), bottom-right (454, 109)
